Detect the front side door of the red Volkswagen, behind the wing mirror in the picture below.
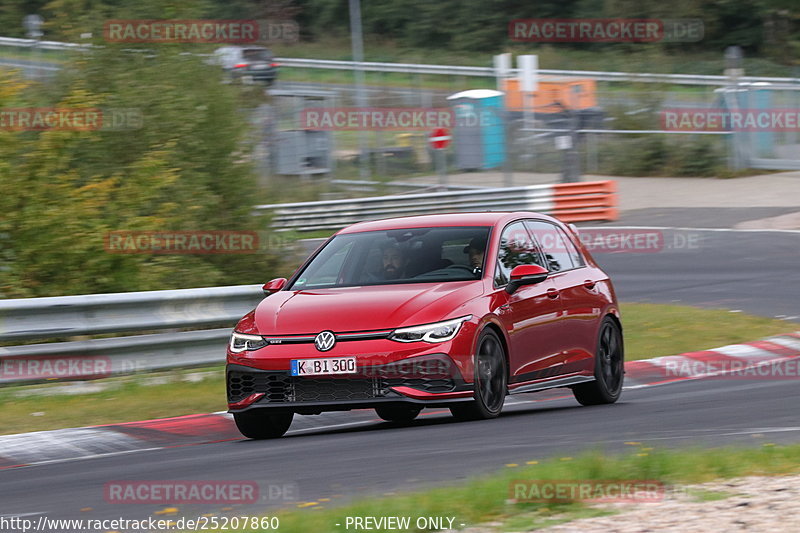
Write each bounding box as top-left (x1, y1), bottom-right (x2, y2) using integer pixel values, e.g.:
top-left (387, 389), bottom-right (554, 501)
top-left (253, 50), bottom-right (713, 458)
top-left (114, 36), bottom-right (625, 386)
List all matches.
top-left (493, 221), bottom-right (562, 384)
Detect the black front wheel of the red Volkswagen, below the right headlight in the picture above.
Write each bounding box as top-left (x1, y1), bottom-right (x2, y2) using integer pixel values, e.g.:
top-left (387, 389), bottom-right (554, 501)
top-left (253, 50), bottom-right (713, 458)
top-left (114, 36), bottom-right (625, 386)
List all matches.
top-left (450, 329), bottom-right (508, 420)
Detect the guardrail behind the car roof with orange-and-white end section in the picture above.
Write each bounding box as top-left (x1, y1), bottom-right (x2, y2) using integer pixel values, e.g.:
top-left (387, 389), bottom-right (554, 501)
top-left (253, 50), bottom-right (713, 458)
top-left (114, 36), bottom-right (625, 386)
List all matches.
top-left (255, 181), bottom-right (617, 231)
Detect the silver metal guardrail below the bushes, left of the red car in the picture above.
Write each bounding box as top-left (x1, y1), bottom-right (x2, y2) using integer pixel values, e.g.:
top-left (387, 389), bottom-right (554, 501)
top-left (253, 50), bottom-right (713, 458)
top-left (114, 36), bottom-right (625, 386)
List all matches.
top-left (0, 285), bottom-right (264, 383)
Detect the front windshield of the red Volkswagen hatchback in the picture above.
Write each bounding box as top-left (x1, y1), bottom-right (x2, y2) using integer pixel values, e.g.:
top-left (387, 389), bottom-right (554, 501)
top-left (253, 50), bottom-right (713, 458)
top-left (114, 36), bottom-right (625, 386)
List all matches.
top-left (289, 227), bottom-right (490, 290)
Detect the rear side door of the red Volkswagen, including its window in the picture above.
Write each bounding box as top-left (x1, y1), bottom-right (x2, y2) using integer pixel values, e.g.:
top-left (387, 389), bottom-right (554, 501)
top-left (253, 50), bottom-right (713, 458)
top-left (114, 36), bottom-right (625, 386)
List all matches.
top-left (525, 220), bottom-right (601, 374)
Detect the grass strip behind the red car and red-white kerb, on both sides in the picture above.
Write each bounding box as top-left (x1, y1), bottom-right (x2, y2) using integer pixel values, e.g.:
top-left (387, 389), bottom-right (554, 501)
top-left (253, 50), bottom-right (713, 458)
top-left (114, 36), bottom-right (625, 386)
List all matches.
top-left (0, 303), bottom-right (793, 434)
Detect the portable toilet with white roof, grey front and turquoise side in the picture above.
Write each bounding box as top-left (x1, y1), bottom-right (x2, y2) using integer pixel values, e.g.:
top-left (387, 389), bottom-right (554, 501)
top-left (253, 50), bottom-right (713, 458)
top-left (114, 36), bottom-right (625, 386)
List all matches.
top-left (447, 89), bottom-right (506, 170)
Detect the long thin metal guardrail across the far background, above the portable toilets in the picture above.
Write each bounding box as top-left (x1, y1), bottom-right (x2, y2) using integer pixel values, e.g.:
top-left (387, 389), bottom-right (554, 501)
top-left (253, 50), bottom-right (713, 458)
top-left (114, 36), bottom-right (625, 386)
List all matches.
top-left (0, 37), bottom-right (800, 86)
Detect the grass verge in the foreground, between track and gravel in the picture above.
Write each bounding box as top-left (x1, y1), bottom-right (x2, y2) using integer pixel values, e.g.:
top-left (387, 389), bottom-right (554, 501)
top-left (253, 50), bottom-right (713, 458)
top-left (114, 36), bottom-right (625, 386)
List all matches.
top-left (244, 443), bottom-right (800, 533)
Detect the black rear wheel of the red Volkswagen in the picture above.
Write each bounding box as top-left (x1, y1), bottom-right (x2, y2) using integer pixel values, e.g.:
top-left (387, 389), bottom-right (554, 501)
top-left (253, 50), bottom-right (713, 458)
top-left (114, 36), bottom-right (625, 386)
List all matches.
top-left (572, 317), bottom-right (625, 405)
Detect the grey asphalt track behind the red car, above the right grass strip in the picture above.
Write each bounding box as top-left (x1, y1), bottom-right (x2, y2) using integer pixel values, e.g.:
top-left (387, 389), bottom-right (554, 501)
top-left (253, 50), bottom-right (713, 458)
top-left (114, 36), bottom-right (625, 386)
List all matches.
top-left (593, 226), bottom-right (800, 322)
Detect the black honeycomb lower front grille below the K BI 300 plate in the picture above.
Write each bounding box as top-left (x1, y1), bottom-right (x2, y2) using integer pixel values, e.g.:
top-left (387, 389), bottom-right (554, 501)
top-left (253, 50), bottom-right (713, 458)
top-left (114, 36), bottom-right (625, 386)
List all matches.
top-left (227, 370), bottom-right (455, 403)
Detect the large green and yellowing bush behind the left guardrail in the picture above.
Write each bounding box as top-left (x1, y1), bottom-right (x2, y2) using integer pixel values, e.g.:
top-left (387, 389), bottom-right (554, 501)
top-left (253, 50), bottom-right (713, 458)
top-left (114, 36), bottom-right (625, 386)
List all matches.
top-left (0, 46), bottom-right (288, 297)
